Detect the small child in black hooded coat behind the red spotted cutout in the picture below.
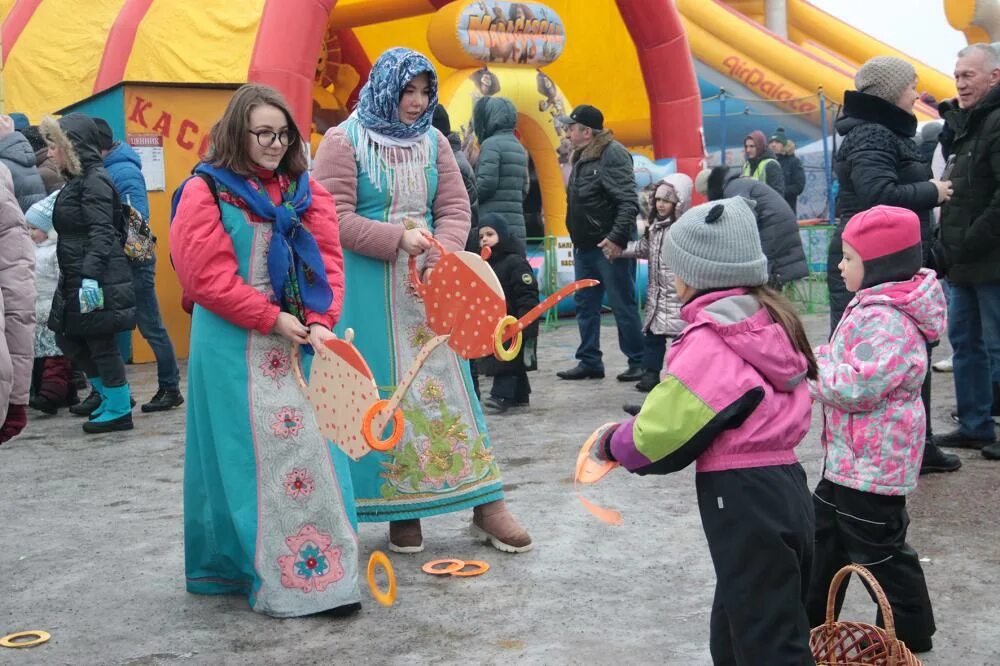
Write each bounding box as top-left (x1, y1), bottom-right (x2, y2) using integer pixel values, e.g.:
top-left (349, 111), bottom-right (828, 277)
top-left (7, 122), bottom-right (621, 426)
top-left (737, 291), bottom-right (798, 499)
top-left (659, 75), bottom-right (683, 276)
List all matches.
top-left (476, 213), bottom-right (538, 414)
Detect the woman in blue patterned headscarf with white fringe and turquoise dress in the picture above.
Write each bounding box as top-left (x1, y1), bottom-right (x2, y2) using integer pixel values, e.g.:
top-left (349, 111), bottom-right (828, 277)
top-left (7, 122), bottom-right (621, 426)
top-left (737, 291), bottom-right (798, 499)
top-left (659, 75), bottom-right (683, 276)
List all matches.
top-left (315, 48), bottom-right (531, 553)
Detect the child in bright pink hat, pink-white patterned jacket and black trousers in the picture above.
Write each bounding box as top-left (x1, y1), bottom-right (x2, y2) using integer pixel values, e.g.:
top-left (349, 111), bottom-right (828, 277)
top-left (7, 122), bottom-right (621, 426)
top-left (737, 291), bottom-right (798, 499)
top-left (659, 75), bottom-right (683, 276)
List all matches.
top-left (808, 206), bottom-right (947, 652)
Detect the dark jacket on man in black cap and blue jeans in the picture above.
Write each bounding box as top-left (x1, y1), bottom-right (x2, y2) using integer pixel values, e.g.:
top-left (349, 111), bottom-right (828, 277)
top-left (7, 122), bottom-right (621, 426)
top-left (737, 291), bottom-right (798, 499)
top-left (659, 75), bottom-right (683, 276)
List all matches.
top-left (566, 129), bottom-right (639, 250)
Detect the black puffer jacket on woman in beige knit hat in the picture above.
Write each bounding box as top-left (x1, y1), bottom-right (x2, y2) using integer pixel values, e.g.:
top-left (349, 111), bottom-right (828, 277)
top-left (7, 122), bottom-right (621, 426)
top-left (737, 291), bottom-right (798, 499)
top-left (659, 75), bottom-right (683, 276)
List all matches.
top-left (827, 90), bottom-right (938, 332)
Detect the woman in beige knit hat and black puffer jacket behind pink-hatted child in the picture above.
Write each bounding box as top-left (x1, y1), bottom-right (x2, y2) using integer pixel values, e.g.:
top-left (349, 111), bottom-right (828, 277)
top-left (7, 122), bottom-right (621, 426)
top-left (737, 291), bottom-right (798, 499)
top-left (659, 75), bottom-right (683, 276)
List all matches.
top-left (827, 56), bottom-right (962, 473)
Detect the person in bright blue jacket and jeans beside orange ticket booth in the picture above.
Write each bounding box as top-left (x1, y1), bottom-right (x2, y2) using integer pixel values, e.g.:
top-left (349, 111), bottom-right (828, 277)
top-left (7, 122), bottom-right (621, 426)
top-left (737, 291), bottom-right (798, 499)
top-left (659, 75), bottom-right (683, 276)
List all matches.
top-left (94, 118), bottom-right (184, 412)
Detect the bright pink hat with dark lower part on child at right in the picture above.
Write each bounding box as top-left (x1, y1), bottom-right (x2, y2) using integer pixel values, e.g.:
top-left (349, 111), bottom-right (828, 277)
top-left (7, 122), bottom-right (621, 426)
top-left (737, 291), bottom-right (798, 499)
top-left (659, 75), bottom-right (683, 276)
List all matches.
top-left (842, 206), bottom-right (923, 289)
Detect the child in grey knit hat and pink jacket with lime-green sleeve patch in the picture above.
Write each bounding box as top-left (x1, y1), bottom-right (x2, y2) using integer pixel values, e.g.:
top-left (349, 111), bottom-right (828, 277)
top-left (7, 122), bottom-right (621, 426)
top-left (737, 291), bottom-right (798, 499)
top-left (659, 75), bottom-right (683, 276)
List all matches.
top-left (597, 197), bottom-right (816, 664)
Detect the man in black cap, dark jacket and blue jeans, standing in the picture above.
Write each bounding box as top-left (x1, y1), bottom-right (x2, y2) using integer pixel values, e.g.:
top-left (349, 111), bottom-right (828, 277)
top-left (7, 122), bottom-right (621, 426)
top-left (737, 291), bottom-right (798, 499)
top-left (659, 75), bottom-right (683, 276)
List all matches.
top-left (557, 104), bottom-right (643, 382)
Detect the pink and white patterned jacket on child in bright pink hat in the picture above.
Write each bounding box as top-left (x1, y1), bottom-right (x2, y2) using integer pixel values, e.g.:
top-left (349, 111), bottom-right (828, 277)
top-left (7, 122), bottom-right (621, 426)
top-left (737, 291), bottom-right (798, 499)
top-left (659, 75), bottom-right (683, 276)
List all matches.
top-left (810, 269), bottom-right (947, 495)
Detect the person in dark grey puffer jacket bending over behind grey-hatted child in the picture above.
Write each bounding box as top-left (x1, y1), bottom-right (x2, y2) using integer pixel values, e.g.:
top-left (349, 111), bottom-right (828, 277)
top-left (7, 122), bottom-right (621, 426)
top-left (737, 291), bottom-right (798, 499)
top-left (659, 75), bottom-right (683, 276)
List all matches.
top-left (695, 166), bottom-right (809, 290)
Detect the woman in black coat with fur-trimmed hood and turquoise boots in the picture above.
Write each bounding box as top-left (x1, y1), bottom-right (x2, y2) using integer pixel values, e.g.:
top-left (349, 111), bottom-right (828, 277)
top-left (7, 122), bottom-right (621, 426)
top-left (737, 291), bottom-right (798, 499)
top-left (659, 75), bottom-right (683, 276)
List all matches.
top-left (41, 113), bottom-right (135, 433)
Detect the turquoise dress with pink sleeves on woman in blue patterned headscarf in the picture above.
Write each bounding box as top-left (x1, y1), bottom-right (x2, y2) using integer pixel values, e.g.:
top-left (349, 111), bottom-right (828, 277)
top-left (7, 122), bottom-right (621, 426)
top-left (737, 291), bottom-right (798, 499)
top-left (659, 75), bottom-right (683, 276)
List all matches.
top-left (314, 118), bottom-right (503, 522)
